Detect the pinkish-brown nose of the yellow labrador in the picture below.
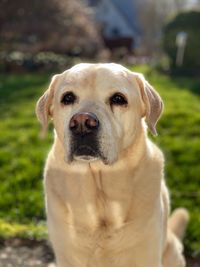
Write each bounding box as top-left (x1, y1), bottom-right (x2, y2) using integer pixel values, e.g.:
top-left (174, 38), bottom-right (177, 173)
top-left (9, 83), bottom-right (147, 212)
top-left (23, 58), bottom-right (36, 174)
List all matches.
top-left (69, 112), bottom-right (99, 134)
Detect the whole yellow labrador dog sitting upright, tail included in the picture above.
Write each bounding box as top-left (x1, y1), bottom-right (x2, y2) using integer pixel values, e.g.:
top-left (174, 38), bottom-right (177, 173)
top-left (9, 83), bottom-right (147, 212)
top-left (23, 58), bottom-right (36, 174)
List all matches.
top-left (36, 64), bottom-right (188, 267)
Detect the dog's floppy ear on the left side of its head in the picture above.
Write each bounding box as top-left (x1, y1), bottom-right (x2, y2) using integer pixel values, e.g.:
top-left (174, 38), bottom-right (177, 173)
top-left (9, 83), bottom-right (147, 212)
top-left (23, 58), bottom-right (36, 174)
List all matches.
top-left (36, 75), bottom-right (59, 136)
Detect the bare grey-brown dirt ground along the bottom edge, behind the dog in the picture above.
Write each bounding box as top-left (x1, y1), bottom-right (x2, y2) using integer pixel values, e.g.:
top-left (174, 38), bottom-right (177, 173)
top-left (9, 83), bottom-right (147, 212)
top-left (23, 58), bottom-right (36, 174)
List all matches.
top-left (0, 238), bottom-right (200, 267)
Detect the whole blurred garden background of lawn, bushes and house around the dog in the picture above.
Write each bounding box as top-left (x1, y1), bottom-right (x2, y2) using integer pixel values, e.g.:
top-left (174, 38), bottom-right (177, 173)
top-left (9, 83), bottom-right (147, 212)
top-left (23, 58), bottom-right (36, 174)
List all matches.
top-left (0, 0), bottom-right (200, 267)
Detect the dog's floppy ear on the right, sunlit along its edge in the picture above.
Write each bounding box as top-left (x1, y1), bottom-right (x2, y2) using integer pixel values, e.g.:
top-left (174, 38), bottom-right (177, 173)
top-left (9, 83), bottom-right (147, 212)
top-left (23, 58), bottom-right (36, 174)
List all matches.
top-left (136, 73), bottom-right (163, 135)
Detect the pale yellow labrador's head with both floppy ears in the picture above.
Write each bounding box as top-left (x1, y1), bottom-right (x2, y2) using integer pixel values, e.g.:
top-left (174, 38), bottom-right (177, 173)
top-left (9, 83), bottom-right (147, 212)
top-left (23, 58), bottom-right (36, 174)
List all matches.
top-left (36, 64), bottom-right (162, 164)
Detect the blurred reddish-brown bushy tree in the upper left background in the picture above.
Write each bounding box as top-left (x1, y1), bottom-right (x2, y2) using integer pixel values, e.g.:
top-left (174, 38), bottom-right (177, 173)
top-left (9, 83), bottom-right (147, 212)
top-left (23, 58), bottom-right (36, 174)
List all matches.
top-left (0, 0), bottom-right (101, 56)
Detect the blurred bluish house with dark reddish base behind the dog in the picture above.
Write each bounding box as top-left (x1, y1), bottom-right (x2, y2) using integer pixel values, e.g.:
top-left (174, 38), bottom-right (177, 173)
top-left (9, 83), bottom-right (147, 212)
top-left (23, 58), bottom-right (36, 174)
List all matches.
top-left (87, 0), bottom-right (141, 53)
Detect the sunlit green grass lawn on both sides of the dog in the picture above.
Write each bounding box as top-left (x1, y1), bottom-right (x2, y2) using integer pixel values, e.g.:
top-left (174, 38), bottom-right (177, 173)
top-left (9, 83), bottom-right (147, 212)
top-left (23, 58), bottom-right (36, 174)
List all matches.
top-left (0, 66), bottom-right (200, 255)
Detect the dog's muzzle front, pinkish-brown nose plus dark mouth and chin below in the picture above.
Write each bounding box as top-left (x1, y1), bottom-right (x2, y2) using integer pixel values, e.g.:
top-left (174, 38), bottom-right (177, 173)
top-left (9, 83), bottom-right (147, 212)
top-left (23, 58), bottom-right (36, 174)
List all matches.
top-left (69, 112), bottom-right (100, 160)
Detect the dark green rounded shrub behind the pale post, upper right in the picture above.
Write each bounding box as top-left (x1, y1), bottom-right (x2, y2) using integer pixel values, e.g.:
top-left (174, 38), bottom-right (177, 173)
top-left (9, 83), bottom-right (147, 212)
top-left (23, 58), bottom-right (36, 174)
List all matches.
top-left (163, 11), bottom-right (200, 74)
